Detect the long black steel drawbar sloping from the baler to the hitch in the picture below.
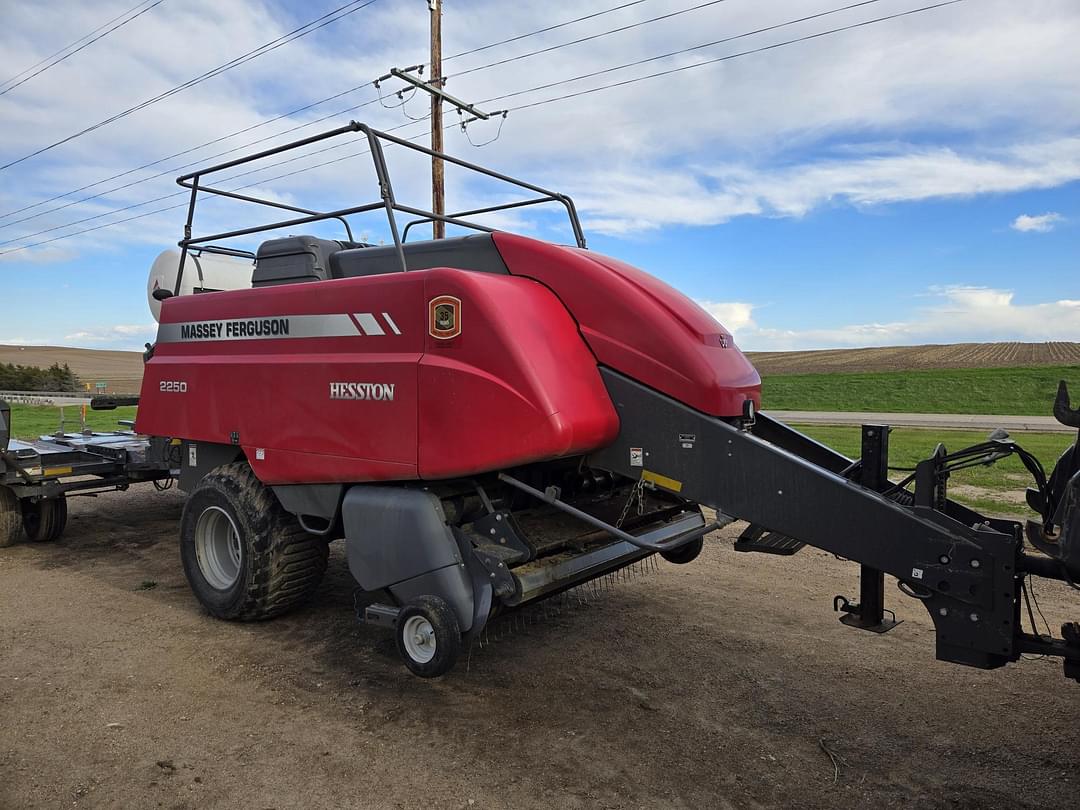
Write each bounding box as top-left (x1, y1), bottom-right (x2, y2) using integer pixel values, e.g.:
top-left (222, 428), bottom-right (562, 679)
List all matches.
top-left (586, 367), bottom-right (1080, 680)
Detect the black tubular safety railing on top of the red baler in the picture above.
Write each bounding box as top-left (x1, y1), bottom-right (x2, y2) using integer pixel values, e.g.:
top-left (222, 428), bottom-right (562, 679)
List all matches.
top-left (173, 121), bottom-right (586, 295)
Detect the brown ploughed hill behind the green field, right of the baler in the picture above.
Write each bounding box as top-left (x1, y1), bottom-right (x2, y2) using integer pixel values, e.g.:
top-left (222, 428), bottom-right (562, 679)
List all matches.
top-left (747, 342), bottom-right (1080, 376)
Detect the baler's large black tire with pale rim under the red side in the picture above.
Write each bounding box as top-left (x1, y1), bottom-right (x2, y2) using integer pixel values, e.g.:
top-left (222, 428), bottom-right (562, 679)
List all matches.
top-left (180, 462), bottom-right (328, 621)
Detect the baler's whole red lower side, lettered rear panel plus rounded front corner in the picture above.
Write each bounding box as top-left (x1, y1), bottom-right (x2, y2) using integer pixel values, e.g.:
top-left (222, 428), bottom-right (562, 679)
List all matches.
top-left (136, 269), bottom-right (618, 484)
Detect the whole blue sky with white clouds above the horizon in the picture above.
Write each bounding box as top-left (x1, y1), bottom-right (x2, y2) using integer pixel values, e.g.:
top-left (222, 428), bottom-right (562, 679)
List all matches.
top-left (0, 0), bottom-right (1080, 349)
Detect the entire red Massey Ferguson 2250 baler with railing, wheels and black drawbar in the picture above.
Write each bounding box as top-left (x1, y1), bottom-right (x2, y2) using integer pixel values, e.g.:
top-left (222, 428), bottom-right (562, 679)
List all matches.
top-left (2, 118), bottom-right (1080, 678)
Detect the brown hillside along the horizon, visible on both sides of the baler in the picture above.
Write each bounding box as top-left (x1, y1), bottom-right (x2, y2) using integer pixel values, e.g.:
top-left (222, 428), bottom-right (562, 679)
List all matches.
top-left (0, 342), bottom-right (1080, 393)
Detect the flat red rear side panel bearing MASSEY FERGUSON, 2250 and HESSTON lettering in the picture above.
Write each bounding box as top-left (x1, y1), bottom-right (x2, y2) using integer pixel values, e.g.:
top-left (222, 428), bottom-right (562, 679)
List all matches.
top-left (136, 273), bottom-right (427, 483)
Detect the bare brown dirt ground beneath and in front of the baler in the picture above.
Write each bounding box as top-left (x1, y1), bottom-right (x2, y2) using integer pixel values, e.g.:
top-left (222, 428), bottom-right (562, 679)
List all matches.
top-left (0, 488), bottom-right (1080, 810)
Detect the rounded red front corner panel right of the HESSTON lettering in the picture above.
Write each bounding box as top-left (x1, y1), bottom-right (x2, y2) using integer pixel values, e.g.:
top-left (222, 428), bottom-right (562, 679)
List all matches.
top-left (419, 270), bottom-right (619, 478)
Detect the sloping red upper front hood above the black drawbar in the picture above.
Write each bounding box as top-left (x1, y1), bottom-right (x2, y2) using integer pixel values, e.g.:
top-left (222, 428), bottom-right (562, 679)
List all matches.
top-left (495, 233), bottom-right (761, 416)
